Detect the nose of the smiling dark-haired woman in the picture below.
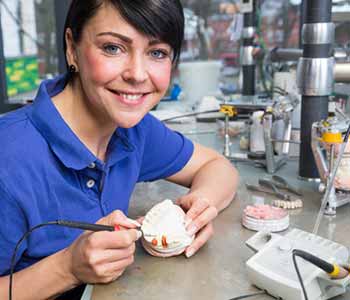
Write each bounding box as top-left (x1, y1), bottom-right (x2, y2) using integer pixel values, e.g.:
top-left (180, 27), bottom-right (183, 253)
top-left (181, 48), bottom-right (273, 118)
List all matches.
top-left (122, 54), bottom-right (148, 84)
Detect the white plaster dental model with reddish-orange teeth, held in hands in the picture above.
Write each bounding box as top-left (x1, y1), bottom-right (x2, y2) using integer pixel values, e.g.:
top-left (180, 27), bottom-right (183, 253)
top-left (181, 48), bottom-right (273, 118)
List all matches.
top-left (141, 199), bottom-right (194, 257)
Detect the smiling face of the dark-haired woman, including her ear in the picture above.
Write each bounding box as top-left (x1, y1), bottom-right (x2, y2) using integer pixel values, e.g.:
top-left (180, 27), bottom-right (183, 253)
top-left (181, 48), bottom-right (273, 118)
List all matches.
top-left (68, 5), bottom-right (172, 128)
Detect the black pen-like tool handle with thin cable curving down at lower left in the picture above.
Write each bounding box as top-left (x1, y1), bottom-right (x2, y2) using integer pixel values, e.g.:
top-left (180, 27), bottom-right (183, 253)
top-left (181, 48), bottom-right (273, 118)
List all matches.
top-left (9, 220), bottom-right (120, 300)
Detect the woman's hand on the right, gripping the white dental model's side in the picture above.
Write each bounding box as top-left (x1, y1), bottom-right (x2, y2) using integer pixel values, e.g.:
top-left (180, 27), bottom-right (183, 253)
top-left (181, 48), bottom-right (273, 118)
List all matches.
top-left (176, 193), bottom-right (218, 257)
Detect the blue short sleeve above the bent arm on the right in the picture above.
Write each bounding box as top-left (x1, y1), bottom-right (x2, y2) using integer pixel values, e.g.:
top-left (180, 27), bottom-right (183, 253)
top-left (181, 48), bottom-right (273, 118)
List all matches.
top-left (138, 114), bottom-right (194, 182)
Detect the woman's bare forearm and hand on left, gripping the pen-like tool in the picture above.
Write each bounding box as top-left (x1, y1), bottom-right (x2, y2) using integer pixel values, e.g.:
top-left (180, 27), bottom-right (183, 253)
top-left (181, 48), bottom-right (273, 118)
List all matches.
top-left (0, 211), bottom-right (141, 300)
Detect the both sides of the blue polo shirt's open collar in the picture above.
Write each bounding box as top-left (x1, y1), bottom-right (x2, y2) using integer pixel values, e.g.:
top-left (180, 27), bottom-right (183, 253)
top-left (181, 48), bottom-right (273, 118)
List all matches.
top-left (28, 75), bottom-right (135, 170)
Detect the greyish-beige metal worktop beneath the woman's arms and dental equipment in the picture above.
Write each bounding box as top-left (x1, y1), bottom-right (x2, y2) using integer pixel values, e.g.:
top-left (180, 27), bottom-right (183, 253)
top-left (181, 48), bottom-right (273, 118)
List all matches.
top-left (87, 123), bottom-right (350, 300)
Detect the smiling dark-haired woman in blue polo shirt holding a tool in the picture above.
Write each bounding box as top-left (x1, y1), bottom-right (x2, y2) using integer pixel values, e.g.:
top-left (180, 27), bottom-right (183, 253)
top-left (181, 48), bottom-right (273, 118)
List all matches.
top-left (0, 0), bottom-right (237, 300)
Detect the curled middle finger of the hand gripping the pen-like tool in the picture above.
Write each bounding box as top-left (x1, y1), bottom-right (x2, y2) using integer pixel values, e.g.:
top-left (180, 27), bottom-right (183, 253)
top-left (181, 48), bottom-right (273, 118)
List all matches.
top-left (87, 243), bottom-right (135, 265)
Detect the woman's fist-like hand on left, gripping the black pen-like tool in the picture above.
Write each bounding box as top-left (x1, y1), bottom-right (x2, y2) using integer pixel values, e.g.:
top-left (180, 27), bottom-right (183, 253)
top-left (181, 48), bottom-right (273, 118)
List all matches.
top-left (66, 211), bottom-right (141, 284)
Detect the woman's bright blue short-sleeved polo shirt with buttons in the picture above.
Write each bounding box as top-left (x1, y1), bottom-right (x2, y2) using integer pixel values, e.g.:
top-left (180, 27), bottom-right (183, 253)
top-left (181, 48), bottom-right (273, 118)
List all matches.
top-left (0, 76), bottom-right (193, 276)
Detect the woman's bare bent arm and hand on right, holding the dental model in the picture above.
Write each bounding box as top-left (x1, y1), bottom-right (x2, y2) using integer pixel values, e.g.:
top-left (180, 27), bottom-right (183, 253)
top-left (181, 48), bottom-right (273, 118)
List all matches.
top-left (168, 144), bottom-right (238, 257)
